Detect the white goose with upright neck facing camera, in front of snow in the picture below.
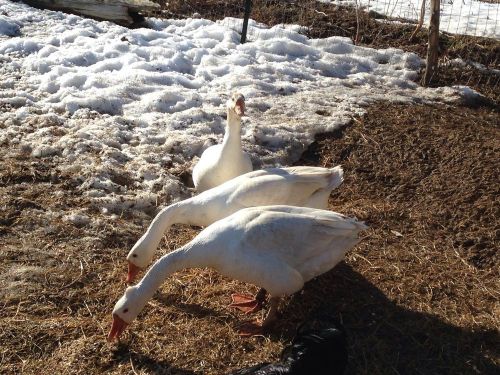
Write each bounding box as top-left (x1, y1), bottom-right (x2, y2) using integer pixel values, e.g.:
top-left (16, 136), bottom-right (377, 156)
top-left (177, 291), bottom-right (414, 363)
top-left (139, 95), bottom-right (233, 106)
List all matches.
top-left (193, 93), bottom-right (253, 192)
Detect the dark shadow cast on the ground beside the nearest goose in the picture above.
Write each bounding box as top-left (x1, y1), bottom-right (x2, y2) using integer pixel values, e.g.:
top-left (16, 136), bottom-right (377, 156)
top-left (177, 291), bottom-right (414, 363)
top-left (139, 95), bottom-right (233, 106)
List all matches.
top-left (273, 263), bottom-right (498, 374)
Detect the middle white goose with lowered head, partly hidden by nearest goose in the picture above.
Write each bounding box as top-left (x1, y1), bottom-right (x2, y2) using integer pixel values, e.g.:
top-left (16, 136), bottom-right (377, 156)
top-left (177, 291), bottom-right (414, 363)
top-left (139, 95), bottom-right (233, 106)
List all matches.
top-left (127, 166), bottom-right (343, 282)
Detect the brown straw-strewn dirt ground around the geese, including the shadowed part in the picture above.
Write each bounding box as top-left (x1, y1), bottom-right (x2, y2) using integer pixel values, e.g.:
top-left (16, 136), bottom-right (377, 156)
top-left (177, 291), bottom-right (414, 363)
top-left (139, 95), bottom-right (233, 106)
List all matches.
top-left (0, 2), bottom-right (500, 374)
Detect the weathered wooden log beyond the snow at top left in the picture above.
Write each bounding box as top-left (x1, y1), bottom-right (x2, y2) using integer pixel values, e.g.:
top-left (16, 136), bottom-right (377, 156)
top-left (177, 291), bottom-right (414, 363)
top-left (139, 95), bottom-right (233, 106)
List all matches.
top-left (25, 0), bottom-right (160, 26)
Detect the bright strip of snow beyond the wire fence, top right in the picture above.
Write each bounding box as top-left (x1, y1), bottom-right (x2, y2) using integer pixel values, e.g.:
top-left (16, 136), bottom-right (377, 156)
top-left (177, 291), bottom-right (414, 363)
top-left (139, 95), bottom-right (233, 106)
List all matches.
top-left (318, 0), bottom-right (500, 39)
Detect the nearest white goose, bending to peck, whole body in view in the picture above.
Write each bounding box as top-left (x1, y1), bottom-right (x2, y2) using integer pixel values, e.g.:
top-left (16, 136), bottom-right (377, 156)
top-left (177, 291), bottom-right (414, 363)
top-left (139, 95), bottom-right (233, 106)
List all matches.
top-left (108, 206), bottom-right (366, 341)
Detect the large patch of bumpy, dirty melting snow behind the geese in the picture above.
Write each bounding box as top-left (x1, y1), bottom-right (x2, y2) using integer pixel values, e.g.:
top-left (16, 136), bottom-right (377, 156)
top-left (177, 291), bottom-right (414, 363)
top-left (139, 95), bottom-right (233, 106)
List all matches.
top-left (0, 0), bottom-right (480, 216)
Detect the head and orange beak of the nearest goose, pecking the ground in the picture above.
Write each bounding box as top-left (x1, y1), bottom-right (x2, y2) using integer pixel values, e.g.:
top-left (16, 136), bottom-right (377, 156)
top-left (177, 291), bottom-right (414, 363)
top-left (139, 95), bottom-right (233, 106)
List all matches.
top-left (108, 287), bottom-right (147, 341)
